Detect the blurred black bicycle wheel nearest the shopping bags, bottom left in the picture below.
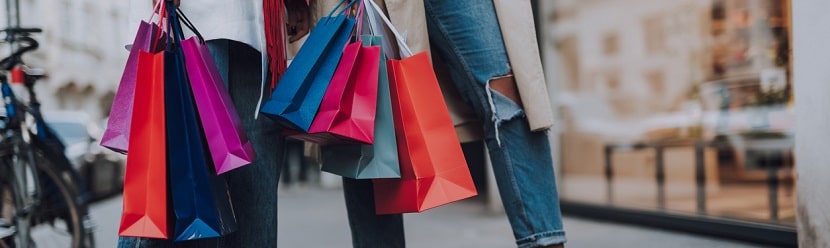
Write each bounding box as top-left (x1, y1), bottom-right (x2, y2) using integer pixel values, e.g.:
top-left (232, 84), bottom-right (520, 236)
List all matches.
top-left (0, 141), bottom-right (94, 248)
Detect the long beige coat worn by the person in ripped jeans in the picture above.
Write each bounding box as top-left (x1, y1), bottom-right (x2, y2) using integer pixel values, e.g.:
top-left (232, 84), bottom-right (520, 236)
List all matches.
top-left (314, 0), bottom-right (553, 142)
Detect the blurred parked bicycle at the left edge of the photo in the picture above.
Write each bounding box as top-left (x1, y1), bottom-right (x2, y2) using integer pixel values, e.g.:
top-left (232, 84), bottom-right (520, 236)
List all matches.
top-left (0, 28), bottom-right (94, 248)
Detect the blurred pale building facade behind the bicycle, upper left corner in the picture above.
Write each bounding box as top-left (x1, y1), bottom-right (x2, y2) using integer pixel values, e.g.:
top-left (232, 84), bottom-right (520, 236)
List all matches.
top-left (0, 0), bottom-right (128, 119)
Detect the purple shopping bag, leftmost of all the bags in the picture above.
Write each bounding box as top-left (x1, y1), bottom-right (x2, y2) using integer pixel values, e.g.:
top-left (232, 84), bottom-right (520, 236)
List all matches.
top-left (101, 21), bottom-right (164, 153)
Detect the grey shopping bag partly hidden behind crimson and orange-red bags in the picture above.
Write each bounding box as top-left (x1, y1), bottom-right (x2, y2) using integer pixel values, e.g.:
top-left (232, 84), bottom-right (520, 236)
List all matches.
top-left (322, 35), bottom-right (401, 179)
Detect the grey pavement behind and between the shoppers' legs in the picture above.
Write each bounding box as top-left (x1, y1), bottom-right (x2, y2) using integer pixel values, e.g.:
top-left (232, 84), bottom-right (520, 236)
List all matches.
top-left (92, 187), bottom-right (772, 248)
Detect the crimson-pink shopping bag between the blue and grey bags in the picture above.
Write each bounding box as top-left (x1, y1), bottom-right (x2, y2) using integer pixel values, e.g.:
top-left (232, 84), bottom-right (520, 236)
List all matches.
top-left (291, 40), bottom-right (380, 145)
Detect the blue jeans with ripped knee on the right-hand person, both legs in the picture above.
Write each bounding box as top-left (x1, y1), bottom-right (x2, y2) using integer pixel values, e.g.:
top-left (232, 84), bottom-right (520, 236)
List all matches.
top-left (343, 0), bottom-right (565, 248)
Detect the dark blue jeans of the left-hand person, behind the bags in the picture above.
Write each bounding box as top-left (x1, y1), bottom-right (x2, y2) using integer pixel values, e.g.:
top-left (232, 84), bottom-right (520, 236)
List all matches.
top-left (118, 40), bottom-right (285, 248)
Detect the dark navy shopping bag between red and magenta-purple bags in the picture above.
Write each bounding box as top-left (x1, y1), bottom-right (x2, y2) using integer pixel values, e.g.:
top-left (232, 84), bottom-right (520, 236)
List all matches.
top-left (164, 8), bottom-right (237, 241)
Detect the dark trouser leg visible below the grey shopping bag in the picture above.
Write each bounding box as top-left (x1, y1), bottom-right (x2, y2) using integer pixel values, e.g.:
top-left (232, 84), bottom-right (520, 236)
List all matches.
top-left (343, 177), bottom-right (406, 248)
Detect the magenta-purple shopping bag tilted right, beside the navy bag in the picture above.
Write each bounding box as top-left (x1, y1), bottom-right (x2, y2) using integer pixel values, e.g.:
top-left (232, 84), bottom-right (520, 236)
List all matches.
top-left (182, 37), bottom-right (255, 174)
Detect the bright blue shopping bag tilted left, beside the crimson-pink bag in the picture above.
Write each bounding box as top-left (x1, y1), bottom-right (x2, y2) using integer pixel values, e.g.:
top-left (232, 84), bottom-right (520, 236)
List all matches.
top-left (260, 1), bottom-right (355, 132)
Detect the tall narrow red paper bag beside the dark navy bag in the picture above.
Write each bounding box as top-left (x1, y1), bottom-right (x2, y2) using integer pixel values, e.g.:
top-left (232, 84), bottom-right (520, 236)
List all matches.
top-left (118, 52), bottom-right (169, 239)
